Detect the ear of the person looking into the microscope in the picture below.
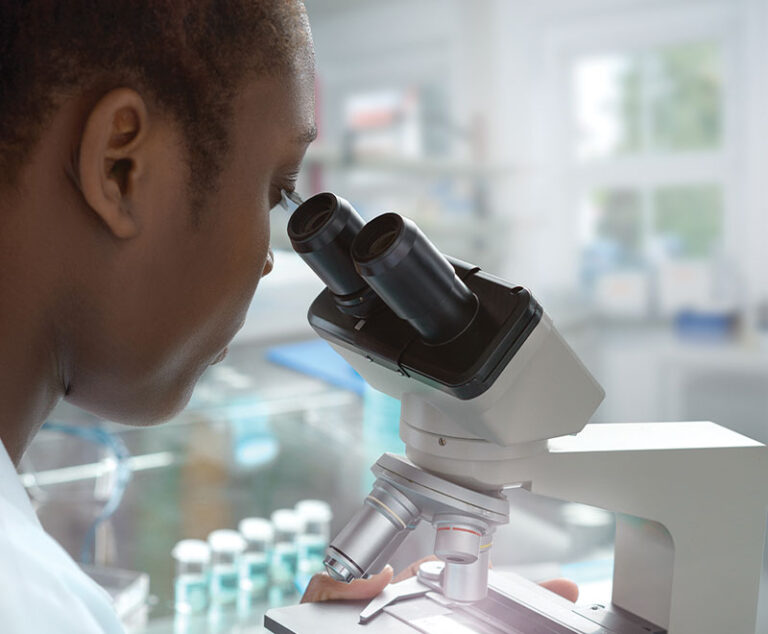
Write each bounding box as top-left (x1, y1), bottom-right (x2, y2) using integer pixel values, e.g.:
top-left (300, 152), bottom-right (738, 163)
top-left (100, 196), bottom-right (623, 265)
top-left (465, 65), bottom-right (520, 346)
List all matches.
top-left (77, 88), bottom-right (149, 239)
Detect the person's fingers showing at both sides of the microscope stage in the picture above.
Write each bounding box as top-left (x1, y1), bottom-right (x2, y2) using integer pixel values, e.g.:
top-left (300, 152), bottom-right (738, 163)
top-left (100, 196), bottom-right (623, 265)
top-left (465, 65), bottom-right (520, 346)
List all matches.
top-left (301, 555), bottom-right (579, 603)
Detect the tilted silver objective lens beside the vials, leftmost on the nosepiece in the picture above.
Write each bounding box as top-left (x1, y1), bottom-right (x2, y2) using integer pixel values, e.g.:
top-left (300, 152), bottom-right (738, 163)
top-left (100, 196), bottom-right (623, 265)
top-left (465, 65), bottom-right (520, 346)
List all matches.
top-left (323, 480), bottom-right (420, 583)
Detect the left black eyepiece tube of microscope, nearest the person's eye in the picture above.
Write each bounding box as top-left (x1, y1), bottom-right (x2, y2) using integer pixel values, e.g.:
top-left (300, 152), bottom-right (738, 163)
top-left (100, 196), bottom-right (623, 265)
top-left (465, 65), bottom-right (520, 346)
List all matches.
top-left (288, 193), bottom-right (379, 317)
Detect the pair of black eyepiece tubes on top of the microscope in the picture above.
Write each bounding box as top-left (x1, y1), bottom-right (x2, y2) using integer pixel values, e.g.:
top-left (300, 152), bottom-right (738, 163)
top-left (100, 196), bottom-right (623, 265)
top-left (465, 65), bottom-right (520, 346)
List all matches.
top-left (288, 193), bottom-right (478, 344)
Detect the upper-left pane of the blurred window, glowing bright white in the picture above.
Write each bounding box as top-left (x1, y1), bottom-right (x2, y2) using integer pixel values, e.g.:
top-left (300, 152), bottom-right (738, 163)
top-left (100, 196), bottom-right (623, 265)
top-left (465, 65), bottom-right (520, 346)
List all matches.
top-left (573, 55), bottom-right (642, 160)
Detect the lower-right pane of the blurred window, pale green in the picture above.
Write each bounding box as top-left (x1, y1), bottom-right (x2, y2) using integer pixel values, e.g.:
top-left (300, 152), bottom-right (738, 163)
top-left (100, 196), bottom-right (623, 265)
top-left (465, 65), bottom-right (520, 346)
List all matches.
top-left (653, 184), bottom-right (723, 258)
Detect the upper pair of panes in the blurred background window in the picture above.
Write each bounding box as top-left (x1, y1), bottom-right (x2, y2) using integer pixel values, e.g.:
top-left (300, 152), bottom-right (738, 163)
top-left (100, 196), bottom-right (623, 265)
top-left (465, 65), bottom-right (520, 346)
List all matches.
top-left (573, 42), bottom-right (723, 161)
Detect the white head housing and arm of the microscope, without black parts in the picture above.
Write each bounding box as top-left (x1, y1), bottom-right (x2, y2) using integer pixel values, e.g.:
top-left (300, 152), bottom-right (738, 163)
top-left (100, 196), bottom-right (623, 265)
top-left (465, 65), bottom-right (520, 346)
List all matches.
top-left (337, 317), bottom-right (768, 634)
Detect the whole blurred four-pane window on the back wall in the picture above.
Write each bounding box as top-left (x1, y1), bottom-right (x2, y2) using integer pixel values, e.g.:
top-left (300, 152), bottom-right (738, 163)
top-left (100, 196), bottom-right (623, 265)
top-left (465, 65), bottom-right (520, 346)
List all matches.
top-left (568, 38), bottom-right (726, 316)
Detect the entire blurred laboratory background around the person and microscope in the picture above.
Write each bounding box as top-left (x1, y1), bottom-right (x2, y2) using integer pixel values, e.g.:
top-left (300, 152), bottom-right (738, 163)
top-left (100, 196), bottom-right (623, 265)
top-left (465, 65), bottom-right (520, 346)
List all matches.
top-left (22, 0), bottom-right (768, 632)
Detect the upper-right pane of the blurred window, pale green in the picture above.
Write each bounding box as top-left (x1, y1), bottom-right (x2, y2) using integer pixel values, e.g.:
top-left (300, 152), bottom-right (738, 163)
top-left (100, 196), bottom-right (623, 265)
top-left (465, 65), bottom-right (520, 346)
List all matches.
top-left (648, 42), bottom-right (723, 150)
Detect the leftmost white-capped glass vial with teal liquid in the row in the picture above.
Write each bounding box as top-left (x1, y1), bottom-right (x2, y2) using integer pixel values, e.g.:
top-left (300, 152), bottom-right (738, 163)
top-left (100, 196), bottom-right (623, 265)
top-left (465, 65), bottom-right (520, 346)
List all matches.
top-left (171, 539), bottom-right (211, 614)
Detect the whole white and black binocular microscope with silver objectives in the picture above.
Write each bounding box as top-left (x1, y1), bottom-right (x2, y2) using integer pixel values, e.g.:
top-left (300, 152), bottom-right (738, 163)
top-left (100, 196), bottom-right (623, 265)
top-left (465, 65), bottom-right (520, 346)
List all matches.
top-left (265, 193), bottom-right (768, 634)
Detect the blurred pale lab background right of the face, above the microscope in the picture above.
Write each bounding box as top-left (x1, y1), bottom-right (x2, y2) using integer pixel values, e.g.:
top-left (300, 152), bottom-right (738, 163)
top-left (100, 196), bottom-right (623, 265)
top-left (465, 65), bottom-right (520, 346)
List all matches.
top-left (286, 0), bottom-right (768, 439)
